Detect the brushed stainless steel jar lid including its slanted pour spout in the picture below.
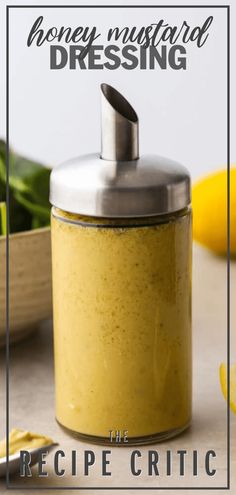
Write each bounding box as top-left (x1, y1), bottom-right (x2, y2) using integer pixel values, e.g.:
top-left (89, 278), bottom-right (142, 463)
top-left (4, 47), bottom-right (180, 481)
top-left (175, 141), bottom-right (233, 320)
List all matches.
top-left (50, 84), bottom-right (190, 218)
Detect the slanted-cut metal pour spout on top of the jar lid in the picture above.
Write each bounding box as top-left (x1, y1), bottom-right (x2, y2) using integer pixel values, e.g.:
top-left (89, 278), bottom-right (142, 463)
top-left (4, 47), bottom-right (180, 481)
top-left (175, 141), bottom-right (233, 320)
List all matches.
top-left (101, 83), bottom-right (139, 161)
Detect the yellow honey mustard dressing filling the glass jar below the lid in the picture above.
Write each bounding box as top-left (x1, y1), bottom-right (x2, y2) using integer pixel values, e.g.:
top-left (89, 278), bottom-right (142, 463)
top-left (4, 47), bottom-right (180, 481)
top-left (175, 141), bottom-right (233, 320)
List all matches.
top-left (52, 209), bottom-right (191, 441)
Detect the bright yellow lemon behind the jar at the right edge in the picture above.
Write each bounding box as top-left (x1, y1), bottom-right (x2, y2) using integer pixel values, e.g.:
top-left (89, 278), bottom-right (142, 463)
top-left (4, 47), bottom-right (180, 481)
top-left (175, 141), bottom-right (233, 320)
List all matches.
top-left (192, 167), bottom-right (236, 256)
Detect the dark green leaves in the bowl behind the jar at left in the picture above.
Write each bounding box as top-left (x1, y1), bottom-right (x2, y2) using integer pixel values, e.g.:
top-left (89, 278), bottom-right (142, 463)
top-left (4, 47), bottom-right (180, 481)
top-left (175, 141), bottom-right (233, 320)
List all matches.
top-left (0, 140), bottom-right (50, 235)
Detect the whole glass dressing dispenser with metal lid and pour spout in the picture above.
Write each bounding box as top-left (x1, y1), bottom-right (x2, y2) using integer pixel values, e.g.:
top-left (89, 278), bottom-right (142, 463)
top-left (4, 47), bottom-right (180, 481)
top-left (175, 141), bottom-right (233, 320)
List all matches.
top-left (50, 85), bottom-right (192, 444)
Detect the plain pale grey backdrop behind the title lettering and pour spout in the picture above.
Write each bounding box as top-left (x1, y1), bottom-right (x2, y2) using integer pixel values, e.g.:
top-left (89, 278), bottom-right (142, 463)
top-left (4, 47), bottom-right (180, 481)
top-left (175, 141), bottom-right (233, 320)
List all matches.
top-left (0, 0), bottom-right (235, 182)
